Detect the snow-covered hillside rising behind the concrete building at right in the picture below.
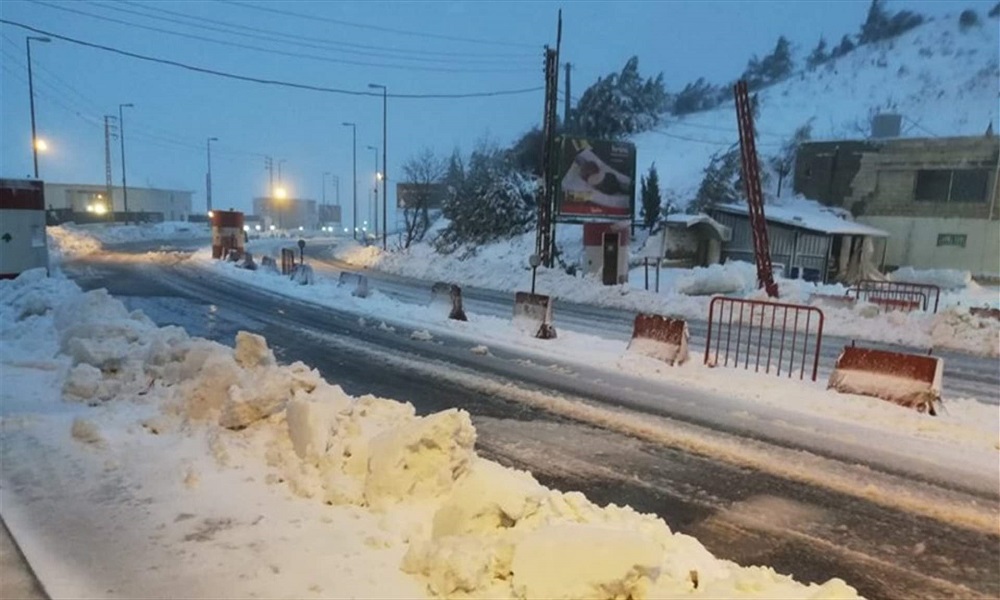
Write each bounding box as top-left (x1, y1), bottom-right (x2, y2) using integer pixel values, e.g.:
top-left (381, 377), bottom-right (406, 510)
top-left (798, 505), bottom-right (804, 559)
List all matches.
top-left (633, 14), bottom-right (1000, 198)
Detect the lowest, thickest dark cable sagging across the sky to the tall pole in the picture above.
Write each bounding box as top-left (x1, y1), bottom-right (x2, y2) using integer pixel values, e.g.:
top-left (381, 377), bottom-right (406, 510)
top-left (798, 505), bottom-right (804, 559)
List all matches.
top-left (0, 18), bottom-right (543, 100)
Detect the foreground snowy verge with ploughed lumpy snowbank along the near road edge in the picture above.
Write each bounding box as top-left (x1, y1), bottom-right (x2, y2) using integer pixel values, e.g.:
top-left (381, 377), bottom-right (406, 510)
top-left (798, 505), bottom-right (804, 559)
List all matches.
top-left (0, 266), bottom-right (868, 598)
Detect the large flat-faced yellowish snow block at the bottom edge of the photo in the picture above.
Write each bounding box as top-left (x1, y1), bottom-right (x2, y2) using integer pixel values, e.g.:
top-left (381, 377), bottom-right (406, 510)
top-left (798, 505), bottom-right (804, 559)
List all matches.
top-left (512, 524), bottom-right (661, 600)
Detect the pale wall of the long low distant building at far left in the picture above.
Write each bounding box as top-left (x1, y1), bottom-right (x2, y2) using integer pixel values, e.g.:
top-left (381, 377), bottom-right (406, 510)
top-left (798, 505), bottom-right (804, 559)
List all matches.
top-left (45, 183), bottom-right (193, 221)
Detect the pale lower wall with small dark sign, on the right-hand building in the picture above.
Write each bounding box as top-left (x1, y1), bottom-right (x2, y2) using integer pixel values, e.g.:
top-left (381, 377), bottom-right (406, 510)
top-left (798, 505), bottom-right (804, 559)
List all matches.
top-left (858, 216), bottom-right (1000, 277)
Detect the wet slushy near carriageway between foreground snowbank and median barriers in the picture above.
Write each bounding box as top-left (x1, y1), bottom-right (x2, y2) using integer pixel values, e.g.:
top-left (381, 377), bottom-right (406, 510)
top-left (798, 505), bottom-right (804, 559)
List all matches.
top-left (67, 253), bottom-right (1000, 598)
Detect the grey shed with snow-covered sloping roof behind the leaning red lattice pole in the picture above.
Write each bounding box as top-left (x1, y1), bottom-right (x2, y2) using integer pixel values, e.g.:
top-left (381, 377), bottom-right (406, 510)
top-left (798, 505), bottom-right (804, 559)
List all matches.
top-left (709, 201), bottom-right (889, 284)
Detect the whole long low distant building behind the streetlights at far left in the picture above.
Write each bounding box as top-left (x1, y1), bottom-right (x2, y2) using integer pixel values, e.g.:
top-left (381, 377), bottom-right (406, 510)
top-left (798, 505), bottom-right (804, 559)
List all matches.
top-left (45, 182), bottom-right (194, 223)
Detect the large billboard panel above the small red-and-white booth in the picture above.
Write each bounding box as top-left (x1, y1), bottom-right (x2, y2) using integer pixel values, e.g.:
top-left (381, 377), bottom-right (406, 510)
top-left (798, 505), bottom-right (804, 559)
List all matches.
top-left (556, 136), bottom-right (635, 219)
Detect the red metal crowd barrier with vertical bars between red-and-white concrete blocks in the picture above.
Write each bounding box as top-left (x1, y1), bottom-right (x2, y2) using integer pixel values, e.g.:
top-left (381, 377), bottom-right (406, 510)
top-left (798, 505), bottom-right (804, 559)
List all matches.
top-left (705, 296), bottom-right (824, 381)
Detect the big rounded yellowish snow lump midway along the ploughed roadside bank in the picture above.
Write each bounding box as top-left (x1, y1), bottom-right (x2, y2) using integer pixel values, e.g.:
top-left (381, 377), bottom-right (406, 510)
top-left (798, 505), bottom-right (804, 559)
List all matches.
top-left (365, 409), bottom-right (476, 506)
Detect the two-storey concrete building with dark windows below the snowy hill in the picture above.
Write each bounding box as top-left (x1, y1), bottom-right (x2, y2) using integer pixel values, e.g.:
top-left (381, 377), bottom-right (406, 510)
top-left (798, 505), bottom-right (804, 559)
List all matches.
top-left (794, 136), bottom-right (1000, 278)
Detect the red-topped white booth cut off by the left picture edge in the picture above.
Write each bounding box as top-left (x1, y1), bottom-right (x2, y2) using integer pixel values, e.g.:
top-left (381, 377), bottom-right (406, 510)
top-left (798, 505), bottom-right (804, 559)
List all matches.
top-left (0, 179), bottom-right (49, 279)
